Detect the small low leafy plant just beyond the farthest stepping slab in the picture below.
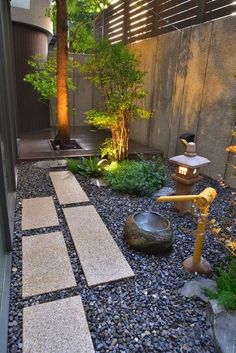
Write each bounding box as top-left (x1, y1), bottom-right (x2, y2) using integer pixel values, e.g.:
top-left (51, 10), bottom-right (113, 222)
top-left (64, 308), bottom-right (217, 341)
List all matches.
top-left (67, 156), bottom-right (106, 177)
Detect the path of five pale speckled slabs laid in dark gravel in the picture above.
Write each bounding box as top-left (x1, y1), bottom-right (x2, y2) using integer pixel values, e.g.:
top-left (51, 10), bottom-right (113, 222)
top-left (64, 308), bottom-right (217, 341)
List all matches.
top-left (22, 171), bottom-right (134, 353)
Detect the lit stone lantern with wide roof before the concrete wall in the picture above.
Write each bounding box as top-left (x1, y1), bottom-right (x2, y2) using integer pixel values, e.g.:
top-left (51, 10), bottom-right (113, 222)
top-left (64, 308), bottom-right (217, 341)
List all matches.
top-left (169, 142), bottom-right (210, 214)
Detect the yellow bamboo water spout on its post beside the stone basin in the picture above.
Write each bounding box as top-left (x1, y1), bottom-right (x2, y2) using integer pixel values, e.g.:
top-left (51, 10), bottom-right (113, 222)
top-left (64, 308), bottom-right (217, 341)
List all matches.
top-left (157, 188), bottom-right (217, 273)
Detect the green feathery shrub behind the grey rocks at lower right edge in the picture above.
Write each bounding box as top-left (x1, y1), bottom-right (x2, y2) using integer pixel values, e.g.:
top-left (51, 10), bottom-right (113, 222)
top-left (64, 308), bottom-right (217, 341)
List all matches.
top-left (205, 257), bottom-right (236, 310)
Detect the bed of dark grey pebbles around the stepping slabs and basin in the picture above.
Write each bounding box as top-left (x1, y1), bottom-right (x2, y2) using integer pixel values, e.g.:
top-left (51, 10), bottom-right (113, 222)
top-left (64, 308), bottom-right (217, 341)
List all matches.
top-left (9, 163), bottom-right (236, 353)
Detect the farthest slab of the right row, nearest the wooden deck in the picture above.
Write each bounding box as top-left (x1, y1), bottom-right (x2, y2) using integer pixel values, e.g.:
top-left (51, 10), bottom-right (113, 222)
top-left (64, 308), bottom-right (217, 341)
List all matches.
top-left (49, 171), bottom-right (89, 205)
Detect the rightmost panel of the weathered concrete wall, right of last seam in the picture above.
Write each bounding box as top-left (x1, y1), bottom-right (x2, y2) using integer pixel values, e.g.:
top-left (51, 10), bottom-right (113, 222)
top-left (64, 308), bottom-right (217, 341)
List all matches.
top-left (196, 17), bottom-right (236, 187)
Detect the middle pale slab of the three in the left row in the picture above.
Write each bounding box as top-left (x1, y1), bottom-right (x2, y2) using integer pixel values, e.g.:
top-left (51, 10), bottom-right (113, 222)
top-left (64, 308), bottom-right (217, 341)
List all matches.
top-left (22, 232), bottom-right (76, 297)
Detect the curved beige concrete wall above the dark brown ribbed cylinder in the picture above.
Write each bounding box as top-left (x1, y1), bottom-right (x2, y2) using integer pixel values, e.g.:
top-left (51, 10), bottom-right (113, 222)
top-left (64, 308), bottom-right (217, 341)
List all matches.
top-left (11, 0), bottom-right (52, 34)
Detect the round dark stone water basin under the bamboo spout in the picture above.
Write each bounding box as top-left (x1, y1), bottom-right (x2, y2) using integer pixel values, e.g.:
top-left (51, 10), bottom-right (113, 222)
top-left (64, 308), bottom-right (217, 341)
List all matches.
top-left (125, 212), bottom-right (174, 254)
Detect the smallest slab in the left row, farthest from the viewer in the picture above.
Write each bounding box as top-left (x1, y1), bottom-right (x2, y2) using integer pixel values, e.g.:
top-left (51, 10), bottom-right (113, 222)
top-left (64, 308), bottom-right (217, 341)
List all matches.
top-left (22, 196), bottom-right (59, 230)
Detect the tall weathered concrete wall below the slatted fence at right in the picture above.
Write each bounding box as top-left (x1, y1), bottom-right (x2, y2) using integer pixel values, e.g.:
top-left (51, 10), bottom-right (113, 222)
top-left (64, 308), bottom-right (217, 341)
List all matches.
top-left (130, 17), bottom-right (236, 187)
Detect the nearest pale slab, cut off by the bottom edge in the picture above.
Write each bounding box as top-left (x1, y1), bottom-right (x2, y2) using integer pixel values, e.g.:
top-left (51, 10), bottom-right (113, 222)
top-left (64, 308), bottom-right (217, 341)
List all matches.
top-left (23, 296), bottom-right (95, 353)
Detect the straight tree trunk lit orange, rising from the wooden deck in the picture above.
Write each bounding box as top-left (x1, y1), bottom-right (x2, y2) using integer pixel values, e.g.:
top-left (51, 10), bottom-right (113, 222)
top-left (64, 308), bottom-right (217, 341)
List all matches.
top-left (56, 0), bottom-right (70, 145)
